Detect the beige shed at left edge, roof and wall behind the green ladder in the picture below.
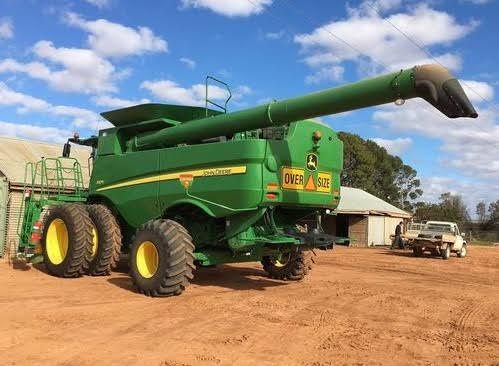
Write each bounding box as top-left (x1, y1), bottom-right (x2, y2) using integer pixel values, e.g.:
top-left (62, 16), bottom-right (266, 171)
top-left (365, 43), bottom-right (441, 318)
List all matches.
top-left (0, 137), bottom-right (91, 257)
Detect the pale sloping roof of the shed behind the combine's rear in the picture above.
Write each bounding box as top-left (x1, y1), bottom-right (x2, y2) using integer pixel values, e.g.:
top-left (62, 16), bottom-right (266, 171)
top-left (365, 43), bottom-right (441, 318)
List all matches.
top-left (335, 187), bottom-right (412, 218)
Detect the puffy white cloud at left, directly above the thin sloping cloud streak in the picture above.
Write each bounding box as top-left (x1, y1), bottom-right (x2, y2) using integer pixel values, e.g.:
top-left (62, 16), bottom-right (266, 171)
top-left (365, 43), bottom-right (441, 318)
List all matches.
top-left (0, 41), bottom-right (123, 93)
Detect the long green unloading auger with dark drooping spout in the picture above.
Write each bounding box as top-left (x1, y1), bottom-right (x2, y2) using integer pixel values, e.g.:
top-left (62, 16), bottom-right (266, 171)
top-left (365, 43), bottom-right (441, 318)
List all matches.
top-left (124, 65), bottom-right (478, 150)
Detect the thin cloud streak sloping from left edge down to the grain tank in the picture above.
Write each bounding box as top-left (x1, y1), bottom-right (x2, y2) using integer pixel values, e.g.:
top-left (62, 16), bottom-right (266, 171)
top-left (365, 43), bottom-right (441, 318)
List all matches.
top-left (0, 82), bottom-right (104, 129)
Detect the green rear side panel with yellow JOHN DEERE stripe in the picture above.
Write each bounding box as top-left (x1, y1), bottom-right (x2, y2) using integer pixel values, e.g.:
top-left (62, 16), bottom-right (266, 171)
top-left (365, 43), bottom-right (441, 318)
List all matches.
top-left (159, 140), bottom-right (267, 217)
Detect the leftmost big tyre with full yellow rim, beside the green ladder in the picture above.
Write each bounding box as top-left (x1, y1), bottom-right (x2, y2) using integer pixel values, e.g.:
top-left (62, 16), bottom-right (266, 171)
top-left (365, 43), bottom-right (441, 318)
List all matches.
top-left (42, 204), bottom-right (93, 277)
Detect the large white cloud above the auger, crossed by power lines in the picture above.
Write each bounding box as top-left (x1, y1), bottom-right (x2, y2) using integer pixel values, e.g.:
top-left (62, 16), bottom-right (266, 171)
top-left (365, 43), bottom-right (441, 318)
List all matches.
top-left (294, 0), bottom-right (477, 81)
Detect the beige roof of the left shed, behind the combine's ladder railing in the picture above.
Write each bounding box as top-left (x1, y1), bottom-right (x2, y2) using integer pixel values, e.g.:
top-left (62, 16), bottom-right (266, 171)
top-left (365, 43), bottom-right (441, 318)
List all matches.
top-left (0, 137), bottom-right (91, 186)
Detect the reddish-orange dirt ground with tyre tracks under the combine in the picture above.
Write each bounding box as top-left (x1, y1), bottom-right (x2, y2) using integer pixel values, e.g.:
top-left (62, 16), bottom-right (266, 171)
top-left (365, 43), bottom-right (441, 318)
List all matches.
top-left (0, 247), bottom-right (499, 366)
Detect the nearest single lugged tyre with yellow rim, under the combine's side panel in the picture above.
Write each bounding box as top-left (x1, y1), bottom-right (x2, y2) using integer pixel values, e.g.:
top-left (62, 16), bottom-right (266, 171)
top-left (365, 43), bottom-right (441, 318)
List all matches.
top-left (130, 219), bottom-right (195, 297)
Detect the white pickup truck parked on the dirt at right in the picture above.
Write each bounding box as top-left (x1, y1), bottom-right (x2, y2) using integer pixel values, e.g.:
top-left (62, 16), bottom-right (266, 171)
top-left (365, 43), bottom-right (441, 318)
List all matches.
top-left (411, 221), bottom-right (467, 259)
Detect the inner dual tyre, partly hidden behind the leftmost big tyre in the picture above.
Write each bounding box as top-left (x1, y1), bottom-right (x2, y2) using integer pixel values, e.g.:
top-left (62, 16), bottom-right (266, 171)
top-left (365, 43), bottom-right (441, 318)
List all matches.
top-left (86, 205), bottom-right (121, 276)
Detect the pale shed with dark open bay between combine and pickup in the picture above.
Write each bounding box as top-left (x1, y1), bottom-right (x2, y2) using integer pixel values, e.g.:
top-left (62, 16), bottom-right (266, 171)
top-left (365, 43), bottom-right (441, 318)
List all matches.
top-left (323, 187), bottom-right (412, 246)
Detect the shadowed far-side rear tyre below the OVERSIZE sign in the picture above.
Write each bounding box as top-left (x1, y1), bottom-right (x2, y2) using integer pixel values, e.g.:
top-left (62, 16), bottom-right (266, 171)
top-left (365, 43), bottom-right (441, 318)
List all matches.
top-left (262, 250), bottom-right (312, 281)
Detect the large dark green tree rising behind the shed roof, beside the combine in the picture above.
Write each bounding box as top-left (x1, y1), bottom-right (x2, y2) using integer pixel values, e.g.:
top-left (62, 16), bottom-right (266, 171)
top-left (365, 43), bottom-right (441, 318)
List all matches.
top-left (338, 132), bottom-right (423, 211)
